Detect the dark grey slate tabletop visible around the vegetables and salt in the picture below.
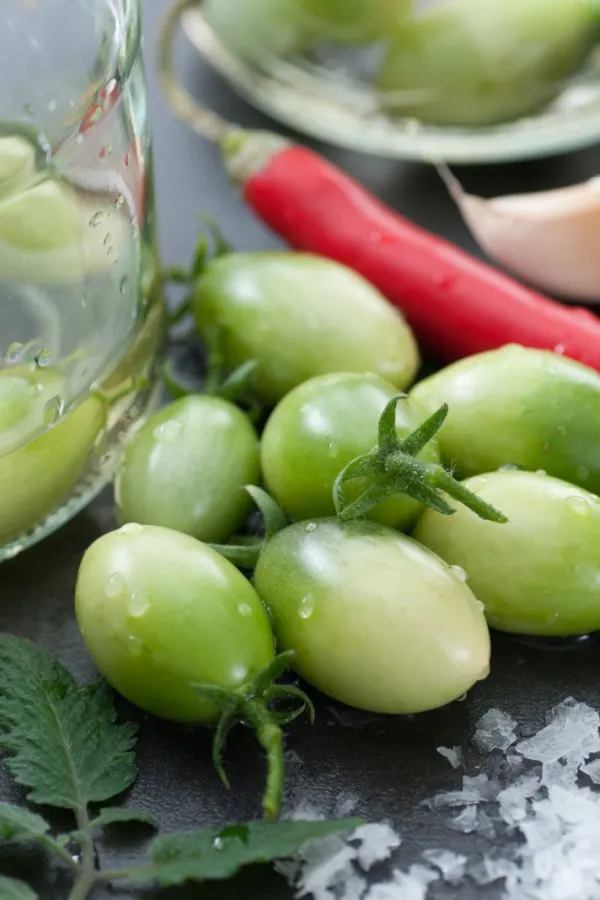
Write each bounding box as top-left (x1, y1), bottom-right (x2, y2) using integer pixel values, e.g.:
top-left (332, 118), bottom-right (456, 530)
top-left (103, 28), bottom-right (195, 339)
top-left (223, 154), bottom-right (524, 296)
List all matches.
top-left (0, 0), bottom-right (600, 900)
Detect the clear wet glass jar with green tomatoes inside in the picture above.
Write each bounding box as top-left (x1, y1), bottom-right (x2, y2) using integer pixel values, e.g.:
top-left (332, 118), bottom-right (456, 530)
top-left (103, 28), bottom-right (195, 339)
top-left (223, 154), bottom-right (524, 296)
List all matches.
top-left (0, 0), bottom-right (164, 560)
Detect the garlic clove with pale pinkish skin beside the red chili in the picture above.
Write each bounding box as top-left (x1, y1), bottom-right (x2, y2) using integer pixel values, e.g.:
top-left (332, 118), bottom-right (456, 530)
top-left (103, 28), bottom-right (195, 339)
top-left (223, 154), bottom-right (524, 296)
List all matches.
top-left (439, 167), bottom-right (600, 302)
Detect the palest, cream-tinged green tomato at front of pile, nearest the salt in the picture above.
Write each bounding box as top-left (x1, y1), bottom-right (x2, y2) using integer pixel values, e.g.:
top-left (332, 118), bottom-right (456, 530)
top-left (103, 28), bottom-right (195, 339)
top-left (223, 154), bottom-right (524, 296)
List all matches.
top-left (254, 519), bottom-right (490, 714)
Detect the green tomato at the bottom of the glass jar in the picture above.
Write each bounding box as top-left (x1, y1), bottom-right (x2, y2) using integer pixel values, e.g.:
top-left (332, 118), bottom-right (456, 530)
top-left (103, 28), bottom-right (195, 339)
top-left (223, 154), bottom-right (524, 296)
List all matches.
top-left (0, 366), bottom-right (106, 544)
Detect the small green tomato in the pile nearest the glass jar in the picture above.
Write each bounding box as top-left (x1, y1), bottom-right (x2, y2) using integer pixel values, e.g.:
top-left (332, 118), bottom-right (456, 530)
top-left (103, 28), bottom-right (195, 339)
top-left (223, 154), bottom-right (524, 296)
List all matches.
top-left (115, 396), bottom-right (260, 543)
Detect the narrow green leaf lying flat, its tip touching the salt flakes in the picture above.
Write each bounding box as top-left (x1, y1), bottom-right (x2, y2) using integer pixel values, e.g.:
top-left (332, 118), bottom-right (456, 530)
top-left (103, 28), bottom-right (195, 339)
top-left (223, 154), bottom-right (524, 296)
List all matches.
top-left (131, 819), bottom-right (362, 887)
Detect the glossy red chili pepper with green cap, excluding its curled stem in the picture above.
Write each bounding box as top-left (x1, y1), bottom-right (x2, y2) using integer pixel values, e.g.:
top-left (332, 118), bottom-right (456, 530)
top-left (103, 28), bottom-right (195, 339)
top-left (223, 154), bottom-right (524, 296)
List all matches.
top-left (224, 132), bottom-right (600, 370)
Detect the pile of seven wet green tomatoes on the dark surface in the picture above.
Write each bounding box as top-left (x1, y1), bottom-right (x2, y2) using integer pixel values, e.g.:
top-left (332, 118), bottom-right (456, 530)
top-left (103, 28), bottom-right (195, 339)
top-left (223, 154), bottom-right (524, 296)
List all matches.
top-left (76, 253), bottom-right (600, 740)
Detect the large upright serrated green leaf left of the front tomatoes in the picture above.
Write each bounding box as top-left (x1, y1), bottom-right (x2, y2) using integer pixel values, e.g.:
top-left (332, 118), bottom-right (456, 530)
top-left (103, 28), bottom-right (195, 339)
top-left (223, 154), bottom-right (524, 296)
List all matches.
top-left (0, 634), bottom-right (136, 810)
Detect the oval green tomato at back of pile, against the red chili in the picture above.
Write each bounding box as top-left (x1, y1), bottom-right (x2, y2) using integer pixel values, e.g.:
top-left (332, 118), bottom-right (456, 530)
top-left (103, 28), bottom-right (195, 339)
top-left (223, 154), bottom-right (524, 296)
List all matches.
top-left (194, 253), bottom-right (419, 403)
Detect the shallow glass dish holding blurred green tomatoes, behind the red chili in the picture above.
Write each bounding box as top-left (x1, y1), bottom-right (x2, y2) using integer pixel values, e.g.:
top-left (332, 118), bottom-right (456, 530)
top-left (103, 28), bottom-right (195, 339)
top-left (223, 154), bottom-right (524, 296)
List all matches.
top-left (183, 0), bottom-right (600, 163)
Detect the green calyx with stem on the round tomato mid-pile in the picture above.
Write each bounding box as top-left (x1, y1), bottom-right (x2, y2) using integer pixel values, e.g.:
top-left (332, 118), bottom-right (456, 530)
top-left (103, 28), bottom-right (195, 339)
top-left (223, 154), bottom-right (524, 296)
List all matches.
top-left (333, 394), bottom-right (508, 523)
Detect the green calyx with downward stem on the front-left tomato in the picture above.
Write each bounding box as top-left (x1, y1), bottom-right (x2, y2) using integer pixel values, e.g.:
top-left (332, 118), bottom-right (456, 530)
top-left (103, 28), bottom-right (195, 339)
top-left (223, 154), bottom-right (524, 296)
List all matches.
top-left (193, 651), bottom-right (315, 819)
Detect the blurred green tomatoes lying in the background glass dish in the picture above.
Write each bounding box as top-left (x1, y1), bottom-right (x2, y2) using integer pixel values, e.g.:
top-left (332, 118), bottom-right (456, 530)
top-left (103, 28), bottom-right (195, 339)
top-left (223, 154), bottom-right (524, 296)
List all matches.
top-left (206, 0), bottom-right (600, 126)
